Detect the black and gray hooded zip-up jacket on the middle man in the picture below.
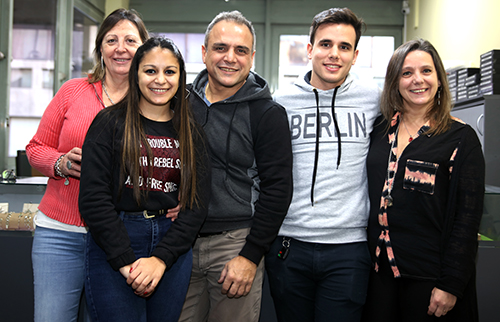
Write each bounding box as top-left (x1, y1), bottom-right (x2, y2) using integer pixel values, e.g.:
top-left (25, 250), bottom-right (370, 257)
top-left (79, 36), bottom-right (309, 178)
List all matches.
top-left (189, 70), bottom-right (292, 264)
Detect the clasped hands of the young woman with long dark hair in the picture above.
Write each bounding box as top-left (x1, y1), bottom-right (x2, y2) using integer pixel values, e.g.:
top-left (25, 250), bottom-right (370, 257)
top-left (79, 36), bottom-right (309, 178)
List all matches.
top-left (125, 256), bottom-right (167, 297)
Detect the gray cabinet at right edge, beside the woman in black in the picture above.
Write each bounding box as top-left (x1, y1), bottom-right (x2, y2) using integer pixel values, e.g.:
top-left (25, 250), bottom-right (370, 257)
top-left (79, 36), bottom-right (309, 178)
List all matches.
top-left (451, 95), bottom-right (500, 321)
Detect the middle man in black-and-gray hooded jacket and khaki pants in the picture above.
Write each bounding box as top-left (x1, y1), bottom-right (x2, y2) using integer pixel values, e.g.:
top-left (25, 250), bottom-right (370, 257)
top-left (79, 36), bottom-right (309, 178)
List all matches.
top-left (179, 11), bottom-right (292, 322)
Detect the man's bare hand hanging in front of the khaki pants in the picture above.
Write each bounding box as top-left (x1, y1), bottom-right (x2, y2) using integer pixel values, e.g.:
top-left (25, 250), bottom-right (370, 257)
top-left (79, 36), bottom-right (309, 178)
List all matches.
top-left (218, 256), bottom-right (257, 298)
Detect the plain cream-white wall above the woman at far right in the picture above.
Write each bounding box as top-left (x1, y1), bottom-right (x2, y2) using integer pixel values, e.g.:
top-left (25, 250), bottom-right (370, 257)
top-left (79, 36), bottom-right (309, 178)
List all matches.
top-left (406, 0), bottom-right (500, 68)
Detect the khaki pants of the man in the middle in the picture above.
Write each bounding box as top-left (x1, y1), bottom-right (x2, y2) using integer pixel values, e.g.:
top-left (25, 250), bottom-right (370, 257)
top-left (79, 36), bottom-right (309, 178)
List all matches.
top-left (179, 228), bottom-right (264, 322)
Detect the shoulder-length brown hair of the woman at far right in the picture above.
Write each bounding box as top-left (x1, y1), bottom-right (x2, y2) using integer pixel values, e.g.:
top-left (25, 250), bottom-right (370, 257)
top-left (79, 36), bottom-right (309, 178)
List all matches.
top-left (380, 39), bottom-right (452, 134)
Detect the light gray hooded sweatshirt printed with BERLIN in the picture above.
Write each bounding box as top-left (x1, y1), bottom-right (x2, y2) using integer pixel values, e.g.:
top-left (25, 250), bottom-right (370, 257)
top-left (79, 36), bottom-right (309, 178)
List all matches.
top-left (274, 72), bottom-right (380, 244)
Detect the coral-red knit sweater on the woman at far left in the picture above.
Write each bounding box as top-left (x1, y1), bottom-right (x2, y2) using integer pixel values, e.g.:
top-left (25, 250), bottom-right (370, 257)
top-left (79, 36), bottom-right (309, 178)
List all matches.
top-left (26, 78), bottom-right (104, 226)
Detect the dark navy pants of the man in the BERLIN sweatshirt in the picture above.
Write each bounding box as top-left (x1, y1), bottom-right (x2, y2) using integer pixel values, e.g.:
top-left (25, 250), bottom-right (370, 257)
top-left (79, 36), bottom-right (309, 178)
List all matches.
top-left (266, 236), bottom-right (371, 322)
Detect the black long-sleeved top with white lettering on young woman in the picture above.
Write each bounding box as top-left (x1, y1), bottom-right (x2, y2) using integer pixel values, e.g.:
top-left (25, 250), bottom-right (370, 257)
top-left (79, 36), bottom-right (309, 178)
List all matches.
top-left (79, 110), bottom-right (210, 270)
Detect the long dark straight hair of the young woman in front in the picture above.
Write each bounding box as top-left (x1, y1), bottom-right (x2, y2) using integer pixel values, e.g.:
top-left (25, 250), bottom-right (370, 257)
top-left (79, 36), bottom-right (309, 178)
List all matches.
top-left (110, 37), bottom-right (199, 209)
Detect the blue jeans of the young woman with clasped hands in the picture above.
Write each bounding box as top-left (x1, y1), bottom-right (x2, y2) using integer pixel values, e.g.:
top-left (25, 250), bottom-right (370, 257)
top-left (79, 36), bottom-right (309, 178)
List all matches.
top-left (85, 212), bottom-right (193, 322)
